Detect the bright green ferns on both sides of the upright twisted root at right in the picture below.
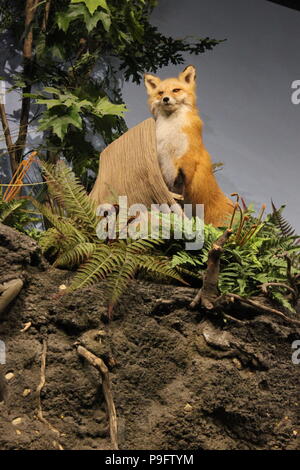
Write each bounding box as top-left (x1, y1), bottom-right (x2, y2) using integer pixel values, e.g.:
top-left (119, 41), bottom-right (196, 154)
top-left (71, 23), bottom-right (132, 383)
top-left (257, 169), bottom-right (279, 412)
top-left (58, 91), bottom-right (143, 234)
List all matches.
top-left (172, 202), bottom-right (300, 311)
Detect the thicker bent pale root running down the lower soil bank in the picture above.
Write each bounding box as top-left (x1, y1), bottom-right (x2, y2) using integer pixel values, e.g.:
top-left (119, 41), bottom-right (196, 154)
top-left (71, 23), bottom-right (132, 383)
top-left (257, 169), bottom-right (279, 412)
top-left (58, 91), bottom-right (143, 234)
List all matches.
top-left (77, 346), bottom-right (118, 450)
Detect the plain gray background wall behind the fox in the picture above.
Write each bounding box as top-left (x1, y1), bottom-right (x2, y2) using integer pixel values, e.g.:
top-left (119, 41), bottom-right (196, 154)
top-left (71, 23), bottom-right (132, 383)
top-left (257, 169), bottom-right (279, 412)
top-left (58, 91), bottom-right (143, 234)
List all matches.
top-left (123, 0), bottom-right (300, 233)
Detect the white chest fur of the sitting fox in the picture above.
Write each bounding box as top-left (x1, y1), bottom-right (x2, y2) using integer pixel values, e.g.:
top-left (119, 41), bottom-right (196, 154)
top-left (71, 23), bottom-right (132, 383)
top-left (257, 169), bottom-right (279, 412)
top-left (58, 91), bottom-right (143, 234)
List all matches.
top-left (156, 109), bottom-right (188, 189)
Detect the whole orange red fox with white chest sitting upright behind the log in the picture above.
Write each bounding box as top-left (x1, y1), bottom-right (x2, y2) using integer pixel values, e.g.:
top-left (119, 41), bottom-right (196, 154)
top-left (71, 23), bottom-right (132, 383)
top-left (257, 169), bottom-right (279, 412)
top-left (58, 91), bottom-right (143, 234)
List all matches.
top-left (144, 65), bottom-right (233, 226)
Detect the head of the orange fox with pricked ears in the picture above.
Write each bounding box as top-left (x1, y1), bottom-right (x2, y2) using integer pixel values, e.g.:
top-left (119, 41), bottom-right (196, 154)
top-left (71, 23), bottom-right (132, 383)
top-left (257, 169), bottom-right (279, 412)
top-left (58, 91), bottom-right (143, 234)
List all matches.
top-left (144, 65), bottom-right (196, 117)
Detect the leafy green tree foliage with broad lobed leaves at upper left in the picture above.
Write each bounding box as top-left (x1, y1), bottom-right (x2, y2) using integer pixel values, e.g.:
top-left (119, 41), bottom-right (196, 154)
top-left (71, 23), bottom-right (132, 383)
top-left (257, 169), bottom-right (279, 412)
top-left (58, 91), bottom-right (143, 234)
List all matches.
top-left (0, 0), bottom-right (220, 190)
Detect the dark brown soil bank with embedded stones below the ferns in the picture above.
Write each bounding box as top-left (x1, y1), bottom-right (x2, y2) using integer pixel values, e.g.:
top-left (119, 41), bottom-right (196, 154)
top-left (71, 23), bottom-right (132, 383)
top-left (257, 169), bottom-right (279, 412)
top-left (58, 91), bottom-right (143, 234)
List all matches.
top-left (0, 225), bottom-right (300, 450)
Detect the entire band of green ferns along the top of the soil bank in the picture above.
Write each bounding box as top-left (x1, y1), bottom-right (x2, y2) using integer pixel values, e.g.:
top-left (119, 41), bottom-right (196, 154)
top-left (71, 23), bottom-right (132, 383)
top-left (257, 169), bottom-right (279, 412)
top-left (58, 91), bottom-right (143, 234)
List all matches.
top-left (33, 162), bottom-right (300, 316)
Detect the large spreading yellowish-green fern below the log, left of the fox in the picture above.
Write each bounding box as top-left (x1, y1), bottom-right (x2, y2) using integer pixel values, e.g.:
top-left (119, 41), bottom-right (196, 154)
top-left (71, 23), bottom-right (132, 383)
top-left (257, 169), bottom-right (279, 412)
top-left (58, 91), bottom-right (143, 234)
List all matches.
top-left (32, 162), bottom-right (184, 309)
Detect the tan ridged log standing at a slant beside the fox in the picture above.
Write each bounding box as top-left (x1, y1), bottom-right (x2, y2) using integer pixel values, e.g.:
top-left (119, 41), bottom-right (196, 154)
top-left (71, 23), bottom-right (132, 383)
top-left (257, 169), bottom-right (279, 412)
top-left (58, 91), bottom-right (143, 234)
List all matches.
top-left (90, 118), bottom-right (182, 214)
